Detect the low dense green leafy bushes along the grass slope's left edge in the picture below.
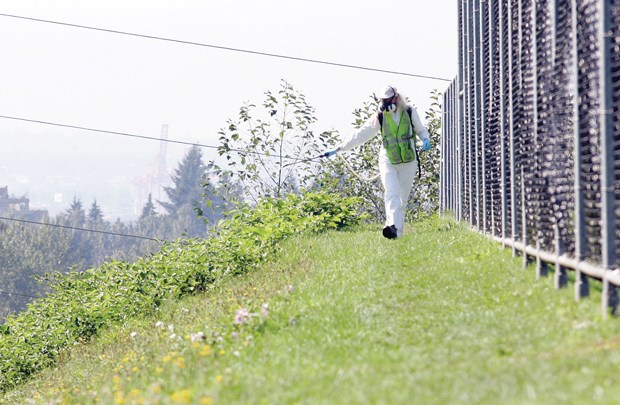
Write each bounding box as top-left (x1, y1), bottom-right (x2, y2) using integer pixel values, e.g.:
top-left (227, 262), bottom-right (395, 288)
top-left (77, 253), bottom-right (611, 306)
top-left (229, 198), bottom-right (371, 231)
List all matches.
top-left (0, 193), bottom-right (360, 391)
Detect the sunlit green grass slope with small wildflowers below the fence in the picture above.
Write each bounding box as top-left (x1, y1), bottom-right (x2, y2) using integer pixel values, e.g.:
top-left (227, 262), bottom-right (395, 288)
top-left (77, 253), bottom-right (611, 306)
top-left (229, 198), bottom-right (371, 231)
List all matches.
top-left (0, 219), bottom-right (620, 404)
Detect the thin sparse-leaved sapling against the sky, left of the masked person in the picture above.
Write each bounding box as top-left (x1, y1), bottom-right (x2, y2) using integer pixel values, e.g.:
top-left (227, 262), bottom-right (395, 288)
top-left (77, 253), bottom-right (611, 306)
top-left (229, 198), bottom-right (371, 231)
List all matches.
top-left (218, 80), bottom-right (335, 203)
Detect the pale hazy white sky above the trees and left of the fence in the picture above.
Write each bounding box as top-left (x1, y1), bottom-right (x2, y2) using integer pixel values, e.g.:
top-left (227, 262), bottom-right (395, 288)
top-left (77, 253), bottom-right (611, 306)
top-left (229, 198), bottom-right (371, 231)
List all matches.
top-left (0, 0), bottom-right (458, 219)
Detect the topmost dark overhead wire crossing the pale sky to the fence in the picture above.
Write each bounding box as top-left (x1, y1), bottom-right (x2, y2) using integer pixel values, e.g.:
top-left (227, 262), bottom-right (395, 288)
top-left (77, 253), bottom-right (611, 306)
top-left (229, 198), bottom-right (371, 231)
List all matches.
top-left (0, 13), bottom-right (452, 82)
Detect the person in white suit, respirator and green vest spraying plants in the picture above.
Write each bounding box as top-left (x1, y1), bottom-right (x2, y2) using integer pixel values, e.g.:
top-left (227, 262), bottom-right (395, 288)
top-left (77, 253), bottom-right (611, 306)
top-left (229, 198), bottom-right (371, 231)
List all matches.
top-left (323, 86), bottom-right (431, 239)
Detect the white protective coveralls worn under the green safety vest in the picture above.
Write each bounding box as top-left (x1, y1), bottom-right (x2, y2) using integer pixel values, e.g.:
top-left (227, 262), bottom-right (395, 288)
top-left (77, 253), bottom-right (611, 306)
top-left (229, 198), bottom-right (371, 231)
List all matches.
top-left (338, 103), bottom-right (430, 236)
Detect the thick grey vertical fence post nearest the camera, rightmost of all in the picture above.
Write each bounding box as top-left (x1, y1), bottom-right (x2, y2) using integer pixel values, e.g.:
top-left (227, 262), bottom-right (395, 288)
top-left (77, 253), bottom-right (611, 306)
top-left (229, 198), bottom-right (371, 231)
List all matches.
top-left (599, 0), bottom-right (617, 317)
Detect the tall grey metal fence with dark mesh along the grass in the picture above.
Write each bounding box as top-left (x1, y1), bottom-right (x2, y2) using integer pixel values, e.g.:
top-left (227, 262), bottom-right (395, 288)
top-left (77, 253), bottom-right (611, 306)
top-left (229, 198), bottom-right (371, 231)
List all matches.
top-left (440, 0), bottom-right (620, 316)
